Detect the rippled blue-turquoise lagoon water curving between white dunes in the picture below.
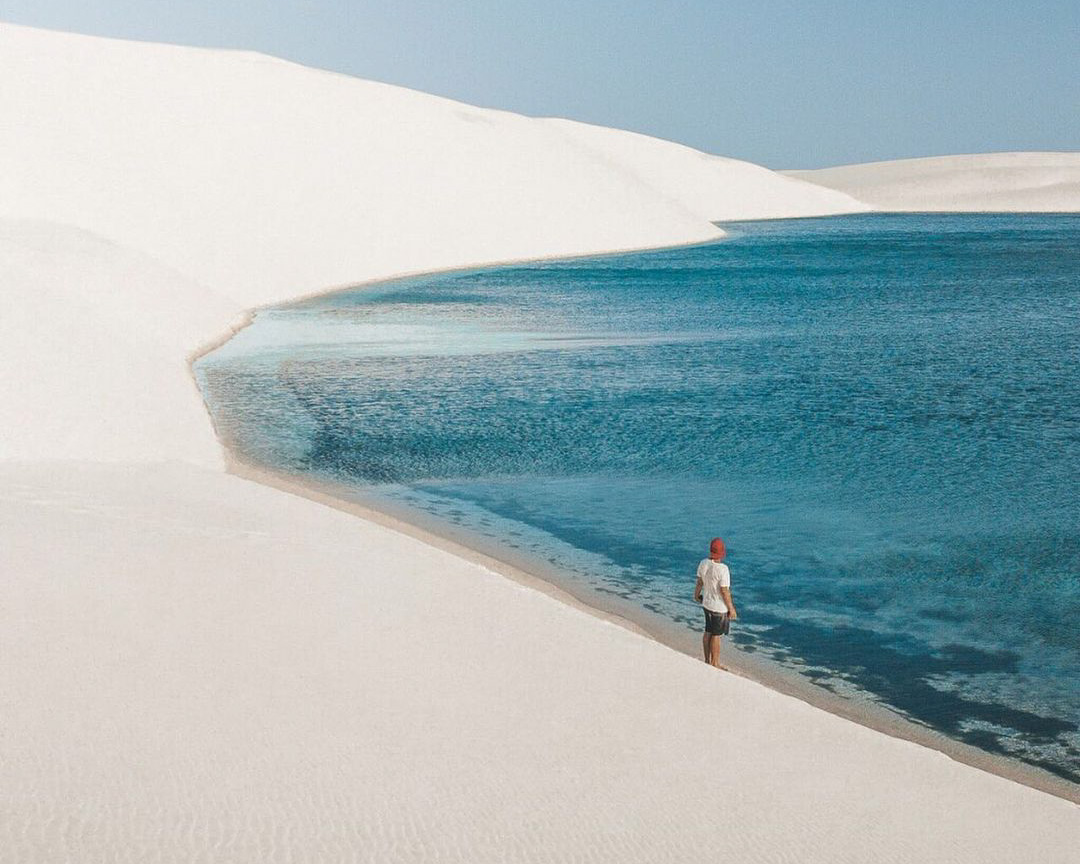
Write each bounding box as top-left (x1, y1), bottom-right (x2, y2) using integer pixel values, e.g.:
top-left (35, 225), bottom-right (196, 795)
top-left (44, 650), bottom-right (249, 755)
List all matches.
top-left (197, 215), bottom-right (1080, 782)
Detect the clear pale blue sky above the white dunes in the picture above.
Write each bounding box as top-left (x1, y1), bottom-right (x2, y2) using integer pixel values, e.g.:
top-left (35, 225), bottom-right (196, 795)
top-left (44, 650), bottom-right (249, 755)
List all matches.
top-left (0, 0), bottom-right (1080, 167)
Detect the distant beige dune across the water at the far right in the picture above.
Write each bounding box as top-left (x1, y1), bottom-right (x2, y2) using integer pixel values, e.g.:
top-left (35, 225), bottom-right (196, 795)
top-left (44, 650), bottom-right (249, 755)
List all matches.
top-left (782, 152), bottom-right (1080, 213)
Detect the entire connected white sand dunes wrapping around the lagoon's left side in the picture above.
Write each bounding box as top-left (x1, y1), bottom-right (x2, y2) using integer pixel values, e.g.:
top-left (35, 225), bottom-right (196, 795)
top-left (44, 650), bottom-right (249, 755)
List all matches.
top-left (0, 25), bottom-right (1080, 864)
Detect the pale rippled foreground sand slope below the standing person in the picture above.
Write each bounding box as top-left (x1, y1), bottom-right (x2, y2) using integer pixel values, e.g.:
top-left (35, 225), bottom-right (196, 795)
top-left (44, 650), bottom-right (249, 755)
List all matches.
top-left (0, 464), bottom-right (1080, 864)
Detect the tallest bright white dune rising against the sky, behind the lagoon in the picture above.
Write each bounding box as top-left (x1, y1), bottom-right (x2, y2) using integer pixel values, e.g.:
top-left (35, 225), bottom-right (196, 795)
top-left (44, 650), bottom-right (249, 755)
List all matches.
top-left (0, 25), bottom-right (858, 317)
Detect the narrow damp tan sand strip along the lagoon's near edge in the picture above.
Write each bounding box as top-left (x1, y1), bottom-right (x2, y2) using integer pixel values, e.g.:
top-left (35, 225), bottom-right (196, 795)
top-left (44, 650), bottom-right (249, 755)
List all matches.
top-left (226, 457), bottom-right (1080, 804)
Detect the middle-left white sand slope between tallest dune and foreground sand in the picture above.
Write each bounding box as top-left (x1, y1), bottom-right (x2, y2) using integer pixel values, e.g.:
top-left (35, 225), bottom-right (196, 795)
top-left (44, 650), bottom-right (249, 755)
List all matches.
top-left (0, 219), bottom-right (237, 465)
